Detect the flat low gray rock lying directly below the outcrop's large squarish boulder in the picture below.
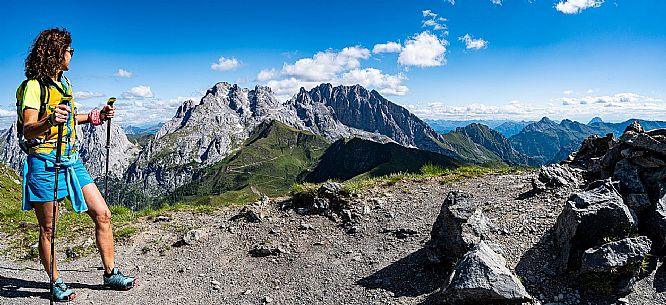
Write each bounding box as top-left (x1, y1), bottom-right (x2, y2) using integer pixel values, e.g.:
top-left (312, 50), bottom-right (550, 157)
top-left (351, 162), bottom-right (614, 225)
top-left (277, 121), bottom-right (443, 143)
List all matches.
top-left (580, 236), bottom-right (652, 273)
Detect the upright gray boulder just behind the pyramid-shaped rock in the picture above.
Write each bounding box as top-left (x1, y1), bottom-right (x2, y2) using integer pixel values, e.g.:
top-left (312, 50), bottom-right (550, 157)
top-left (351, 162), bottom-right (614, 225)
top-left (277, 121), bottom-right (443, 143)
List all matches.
top-left (426, 191), bottom-right (490, 265)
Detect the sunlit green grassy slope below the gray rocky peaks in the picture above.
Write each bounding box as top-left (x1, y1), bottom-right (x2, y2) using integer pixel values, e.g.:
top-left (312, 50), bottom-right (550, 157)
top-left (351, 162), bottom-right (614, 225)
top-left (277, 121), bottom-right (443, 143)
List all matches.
top-left (168, 121), bottom-right (329, 201)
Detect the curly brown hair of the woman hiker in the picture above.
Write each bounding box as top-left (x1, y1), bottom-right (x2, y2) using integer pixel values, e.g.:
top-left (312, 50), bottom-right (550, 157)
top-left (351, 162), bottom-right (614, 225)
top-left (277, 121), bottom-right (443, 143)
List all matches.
top-left (25, 28), bottom-right (72, 82)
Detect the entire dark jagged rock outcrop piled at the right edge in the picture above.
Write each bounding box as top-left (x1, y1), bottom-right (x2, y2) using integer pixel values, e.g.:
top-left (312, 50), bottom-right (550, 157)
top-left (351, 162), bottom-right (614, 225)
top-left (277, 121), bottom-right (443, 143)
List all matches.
top-left (554, 122), bottom-right (666, 293)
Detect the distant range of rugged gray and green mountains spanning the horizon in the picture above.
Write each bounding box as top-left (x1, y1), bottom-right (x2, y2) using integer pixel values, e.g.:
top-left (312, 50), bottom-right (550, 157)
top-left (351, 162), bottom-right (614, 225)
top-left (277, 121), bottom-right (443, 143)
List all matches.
top-left (0, 83), bottom-right (666, 208)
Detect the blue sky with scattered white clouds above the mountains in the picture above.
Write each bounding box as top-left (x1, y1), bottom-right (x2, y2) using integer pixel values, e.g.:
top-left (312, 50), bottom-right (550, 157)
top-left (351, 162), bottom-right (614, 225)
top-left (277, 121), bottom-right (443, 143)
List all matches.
top-left (0, 0), bottom-right (666, 128)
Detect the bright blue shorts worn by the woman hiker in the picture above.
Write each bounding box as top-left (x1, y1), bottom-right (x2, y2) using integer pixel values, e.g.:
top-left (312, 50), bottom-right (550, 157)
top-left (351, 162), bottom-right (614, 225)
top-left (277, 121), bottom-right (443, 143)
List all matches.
top-left (27, 154), bottom-right (95, 202)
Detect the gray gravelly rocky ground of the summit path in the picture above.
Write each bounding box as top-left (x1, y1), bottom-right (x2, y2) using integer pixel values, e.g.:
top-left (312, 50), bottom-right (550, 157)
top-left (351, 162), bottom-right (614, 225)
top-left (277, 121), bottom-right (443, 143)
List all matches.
top-left (0, 172), bottom-right (666, 305)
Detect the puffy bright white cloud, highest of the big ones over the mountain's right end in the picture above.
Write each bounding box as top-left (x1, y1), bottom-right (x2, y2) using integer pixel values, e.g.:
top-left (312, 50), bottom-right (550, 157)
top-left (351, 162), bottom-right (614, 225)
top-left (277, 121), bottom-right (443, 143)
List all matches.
top-left (398, 31), bottom-right (448, 68)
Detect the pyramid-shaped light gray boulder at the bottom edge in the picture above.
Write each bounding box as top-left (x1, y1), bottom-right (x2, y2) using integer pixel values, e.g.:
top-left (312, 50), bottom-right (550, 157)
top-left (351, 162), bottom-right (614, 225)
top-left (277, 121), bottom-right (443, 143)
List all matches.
top-left (441, 241), bottom-right (532, 305)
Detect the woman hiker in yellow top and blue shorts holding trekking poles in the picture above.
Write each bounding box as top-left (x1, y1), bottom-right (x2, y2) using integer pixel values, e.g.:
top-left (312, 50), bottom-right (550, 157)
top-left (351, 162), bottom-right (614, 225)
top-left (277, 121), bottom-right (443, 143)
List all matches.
top-left (17, 28), bottom-right (136, 301)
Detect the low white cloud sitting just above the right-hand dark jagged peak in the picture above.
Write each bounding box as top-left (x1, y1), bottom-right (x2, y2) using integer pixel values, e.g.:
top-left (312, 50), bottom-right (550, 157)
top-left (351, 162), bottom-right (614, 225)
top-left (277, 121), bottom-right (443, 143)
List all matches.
top-left (341, 68), bottom-right (409, 95)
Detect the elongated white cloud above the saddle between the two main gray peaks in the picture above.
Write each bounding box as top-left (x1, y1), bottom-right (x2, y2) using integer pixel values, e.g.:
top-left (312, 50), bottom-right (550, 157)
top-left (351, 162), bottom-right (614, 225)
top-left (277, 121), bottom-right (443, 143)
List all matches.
top-left (282, 46), bottom-right (370, 82)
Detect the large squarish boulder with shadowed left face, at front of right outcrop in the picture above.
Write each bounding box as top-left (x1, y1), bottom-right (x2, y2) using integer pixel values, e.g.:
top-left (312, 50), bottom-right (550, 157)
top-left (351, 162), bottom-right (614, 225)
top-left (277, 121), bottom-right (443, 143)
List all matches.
top-left (554, 181), bottom-right (637, 274)
